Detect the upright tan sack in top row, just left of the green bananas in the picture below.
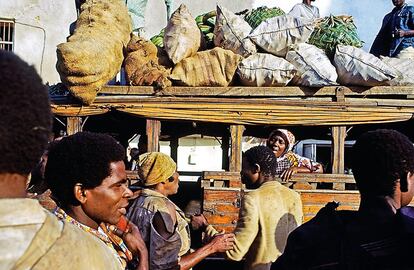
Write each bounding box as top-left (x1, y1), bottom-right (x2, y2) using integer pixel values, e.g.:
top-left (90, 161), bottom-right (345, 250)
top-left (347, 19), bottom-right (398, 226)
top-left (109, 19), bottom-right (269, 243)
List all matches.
top-left (164, 4), bottom-right (201, 64)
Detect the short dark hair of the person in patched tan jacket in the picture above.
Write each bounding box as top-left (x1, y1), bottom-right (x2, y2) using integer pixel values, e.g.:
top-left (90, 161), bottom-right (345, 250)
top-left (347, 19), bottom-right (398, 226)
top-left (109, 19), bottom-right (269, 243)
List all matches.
top-left (243, 145), bottom-right (277, 176)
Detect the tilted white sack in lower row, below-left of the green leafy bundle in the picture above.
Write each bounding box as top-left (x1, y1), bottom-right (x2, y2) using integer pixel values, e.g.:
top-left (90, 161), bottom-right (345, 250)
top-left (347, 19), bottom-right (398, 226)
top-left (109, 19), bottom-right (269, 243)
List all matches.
top-left (286, 43), bottom-right (338, 87)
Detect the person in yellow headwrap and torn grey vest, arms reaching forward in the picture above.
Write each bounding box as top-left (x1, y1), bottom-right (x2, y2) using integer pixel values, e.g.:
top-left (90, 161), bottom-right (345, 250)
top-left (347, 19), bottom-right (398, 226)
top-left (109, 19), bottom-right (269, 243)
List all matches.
top-left (127, 152), bottom-right (234, 270)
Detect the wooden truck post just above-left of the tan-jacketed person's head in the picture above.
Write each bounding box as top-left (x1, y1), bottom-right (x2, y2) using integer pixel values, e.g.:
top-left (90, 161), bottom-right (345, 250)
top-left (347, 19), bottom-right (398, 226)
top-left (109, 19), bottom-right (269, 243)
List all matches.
top-left (229, 125), bottom-right (245, 172)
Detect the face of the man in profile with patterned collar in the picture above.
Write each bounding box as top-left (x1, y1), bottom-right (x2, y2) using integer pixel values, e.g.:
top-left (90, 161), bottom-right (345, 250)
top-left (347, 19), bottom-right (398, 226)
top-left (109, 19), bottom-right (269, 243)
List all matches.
top-left (83, 161), bottom-right (132, 224)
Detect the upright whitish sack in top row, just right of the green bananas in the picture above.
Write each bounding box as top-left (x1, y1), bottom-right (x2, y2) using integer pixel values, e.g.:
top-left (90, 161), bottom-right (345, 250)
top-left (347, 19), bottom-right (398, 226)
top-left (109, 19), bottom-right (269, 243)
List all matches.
top-left (214, 5), bottom-right (256, 57)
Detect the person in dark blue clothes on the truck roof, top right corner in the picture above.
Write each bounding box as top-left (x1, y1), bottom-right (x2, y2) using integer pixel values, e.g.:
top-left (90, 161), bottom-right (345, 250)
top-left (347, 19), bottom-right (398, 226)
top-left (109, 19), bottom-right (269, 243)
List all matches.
top-left (370, 0), bottom-right (414, 57)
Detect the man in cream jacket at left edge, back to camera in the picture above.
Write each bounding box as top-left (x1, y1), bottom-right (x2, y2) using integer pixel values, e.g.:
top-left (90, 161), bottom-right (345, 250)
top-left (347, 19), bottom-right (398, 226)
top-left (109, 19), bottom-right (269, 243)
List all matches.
top-left (0, 50), bottom-right (120, 270)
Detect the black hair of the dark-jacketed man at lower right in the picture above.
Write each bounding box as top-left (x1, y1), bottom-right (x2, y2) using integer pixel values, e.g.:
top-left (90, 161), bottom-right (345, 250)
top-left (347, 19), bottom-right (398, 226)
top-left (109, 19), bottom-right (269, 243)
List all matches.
top-left (352, 129), bottom-right (414, 196)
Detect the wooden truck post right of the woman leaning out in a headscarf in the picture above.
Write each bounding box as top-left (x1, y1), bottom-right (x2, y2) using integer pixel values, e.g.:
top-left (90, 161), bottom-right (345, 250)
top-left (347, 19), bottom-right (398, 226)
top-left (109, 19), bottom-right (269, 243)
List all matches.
top-left (331, 126), bottom-right (346, 190)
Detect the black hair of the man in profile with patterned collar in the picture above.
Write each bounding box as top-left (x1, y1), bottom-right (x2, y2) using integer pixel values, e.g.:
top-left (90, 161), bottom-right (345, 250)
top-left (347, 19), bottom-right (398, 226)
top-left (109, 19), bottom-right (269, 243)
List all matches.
top-left (45, 132), bottom-right (125, 209)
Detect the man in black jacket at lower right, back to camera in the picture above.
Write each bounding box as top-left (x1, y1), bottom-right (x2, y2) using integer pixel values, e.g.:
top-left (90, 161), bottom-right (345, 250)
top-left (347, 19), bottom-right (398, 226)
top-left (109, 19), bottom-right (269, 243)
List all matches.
top-left (271, 129), bottom-right (414, 269)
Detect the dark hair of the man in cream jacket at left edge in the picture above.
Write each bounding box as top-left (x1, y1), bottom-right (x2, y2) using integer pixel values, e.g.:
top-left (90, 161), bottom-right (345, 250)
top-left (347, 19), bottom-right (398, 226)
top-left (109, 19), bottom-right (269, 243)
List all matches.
top-left (0, 50), bottom-right (52, 175)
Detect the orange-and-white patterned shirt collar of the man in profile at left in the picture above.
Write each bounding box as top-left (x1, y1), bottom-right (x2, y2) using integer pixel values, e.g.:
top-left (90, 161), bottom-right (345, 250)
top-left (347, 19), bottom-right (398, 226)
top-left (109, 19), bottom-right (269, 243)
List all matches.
top-left (53, 207), bottom-right (132, 268)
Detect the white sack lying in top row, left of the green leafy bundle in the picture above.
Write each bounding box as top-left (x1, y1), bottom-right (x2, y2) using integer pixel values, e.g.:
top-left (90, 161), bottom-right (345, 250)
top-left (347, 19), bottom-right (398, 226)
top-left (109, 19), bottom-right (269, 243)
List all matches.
top-left (249, 15), bottom-right (314, 57)
